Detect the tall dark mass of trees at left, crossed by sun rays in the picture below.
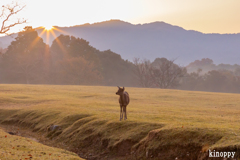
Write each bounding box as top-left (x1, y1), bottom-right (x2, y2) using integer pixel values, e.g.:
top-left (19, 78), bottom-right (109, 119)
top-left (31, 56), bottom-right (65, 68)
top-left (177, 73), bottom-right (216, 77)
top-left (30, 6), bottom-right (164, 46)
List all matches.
top-left (0, 27), bottom-right (134, 85)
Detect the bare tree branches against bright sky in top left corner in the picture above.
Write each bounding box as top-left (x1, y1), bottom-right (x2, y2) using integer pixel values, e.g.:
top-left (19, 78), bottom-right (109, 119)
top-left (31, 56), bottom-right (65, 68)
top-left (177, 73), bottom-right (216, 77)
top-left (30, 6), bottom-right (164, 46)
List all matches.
top-left (0, 2), bottom-right (27, 34)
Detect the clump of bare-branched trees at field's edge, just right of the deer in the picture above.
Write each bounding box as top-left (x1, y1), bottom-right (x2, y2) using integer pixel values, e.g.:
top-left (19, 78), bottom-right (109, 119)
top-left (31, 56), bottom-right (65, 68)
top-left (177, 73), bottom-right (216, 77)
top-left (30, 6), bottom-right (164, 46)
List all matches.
top-left (133, 58), bottom-right (186, 88)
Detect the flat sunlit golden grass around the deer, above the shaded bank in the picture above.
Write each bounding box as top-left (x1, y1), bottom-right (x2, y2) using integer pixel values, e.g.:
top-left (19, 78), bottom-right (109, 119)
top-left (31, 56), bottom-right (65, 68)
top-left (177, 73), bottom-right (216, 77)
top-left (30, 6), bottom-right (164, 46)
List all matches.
top-left (0, 85), bottom-right (240, 131)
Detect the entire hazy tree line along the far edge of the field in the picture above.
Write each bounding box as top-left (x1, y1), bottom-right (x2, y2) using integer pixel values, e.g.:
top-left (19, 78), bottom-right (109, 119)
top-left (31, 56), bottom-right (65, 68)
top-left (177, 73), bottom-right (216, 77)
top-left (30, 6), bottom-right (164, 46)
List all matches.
top-left (0, 27), bottom-right (240, 93)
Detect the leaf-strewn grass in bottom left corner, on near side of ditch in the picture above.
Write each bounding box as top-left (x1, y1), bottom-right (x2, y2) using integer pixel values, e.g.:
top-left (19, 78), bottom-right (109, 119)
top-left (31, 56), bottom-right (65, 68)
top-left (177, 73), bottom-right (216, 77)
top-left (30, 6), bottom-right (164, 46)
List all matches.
top-left (0, 129), bottom-right (80, 160)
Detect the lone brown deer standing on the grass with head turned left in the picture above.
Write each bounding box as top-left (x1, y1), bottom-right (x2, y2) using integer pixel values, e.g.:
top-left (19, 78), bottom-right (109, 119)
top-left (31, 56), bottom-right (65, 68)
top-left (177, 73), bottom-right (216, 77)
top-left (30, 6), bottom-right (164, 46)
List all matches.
top-left (116, 86), bottom-right (130, 121)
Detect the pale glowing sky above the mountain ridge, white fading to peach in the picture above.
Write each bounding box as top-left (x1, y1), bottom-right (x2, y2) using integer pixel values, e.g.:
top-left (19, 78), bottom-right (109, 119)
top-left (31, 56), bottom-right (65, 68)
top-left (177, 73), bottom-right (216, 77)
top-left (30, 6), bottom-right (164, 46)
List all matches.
top-left (0, 0), bottom-right (240, 33)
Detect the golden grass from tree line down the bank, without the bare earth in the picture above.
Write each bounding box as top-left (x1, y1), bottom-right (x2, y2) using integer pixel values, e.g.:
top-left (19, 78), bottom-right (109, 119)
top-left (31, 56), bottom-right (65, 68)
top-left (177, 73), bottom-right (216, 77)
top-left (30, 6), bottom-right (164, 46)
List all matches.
top-left (0, 85), bottom-right (240, 159)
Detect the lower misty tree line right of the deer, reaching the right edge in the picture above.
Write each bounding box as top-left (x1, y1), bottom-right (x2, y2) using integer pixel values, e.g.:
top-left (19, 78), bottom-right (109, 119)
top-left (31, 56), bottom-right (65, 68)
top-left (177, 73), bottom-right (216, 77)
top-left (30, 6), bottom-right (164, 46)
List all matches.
top-left (134, 58), bottom-right (240, 93)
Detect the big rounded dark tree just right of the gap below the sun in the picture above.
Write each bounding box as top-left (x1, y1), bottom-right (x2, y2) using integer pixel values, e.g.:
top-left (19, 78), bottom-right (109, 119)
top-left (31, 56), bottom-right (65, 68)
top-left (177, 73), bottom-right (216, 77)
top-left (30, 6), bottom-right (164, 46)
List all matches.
top-left (51, 35), bottom-right (101, 84)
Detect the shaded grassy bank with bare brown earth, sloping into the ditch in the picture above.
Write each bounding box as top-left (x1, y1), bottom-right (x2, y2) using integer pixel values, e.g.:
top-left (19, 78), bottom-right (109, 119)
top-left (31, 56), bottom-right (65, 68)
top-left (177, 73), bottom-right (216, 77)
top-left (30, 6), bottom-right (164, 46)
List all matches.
top-left (0, 111), bottom-right (240, 160)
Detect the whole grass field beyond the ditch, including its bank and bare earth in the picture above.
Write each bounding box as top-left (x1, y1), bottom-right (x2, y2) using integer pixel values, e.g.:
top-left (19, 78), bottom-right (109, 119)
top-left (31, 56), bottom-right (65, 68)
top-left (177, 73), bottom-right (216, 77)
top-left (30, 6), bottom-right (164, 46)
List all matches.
top-left (0, 85), bottom-right (240, 159)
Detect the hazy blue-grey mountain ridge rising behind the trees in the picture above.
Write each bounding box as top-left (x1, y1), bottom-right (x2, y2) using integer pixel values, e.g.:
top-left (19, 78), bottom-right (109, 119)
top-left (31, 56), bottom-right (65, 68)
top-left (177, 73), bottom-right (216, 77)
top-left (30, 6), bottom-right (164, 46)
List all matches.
top-left (0, 20), bottom-right (240, 65)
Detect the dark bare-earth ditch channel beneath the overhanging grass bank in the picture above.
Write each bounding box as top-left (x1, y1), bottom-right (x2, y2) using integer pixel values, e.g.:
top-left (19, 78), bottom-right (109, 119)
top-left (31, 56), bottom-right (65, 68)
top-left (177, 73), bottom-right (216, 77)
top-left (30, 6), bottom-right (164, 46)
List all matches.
top-left (0, 125), bottom-right (240, 160)
